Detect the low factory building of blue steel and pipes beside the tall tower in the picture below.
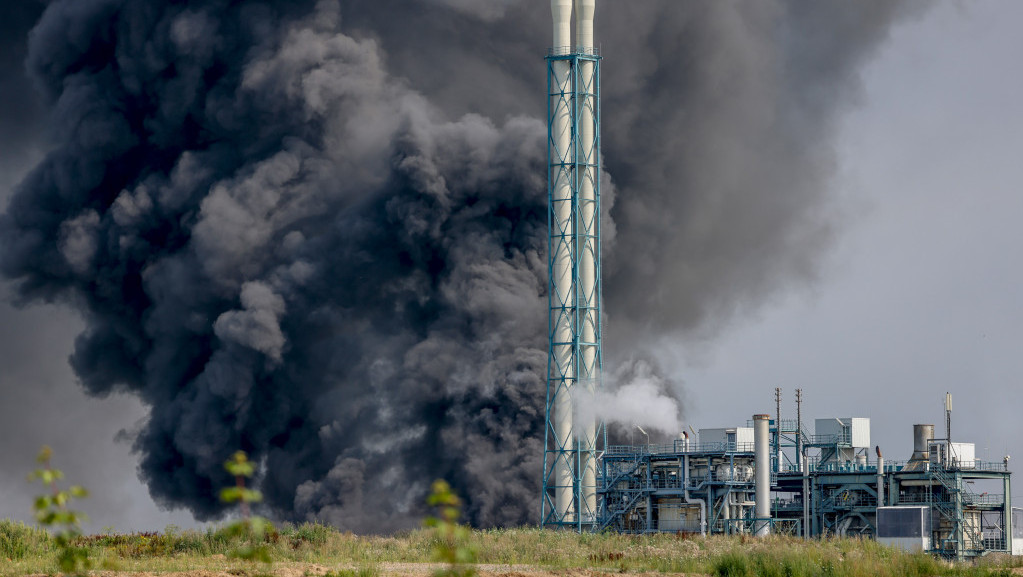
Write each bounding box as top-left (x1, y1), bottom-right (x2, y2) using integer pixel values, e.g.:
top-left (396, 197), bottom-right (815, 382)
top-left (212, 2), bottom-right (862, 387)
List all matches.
top-left (598, 392), bottom-right (1023, 560)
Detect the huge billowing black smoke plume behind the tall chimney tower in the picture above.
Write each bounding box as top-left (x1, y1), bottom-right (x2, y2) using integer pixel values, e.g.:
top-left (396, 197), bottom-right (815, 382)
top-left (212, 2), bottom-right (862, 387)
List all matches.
top-left (0, 0), bottom-right (924, 531)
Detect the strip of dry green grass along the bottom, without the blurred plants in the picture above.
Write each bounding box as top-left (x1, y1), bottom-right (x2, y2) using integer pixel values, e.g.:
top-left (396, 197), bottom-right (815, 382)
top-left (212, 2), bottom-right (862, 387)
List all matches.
top-left (0, 521), bottom-right (1020, 577)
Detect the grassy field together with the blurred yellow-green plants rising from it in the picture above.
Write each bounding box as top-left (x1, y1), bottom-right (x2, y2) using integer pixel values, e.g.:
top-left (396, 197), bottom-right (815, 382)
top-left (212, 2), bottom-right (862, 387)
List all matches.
top-left (0, 458), bottom-right (1023, 577)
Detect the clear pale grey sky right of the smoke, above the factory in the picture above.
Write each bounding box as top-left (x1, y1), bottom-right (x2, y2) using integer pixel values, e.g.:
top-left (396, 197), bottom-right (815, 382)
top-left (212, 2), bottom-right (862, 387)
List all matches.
top-left (675, 1), bottom-right (1023, 502)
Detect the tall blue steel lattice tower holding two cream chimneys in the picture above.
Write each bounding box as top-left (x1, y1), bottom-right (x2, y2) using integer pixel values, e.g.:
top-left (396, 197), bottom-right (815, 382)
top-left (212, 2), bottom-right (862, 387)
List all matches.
top-left (540, 0), bottom-right (606, 531)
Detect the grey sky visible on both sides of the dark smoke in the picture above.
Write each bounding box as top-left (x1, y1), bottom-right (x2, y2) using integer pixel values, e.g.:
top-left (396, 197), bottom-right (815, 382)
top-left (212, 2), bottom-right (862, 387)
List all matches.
top-left (0, 0), bottom-right (1023, 530)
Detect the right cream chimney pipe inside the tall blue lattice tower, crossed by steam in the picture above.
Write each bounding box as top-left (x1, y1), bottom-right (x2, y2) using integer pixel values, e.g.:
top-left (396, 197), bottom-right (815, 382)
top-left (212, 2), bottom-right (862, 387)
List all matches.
top-left (575, 0), bottom-right (601, 517)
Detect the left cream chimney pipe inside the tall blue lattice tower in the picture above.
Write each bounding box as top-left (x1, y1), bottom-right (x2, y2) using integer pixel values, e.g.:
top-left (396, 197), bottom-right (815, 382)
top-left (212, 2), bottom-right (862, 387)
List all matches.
top-left (547, 0), bottom-right (576, 523)
